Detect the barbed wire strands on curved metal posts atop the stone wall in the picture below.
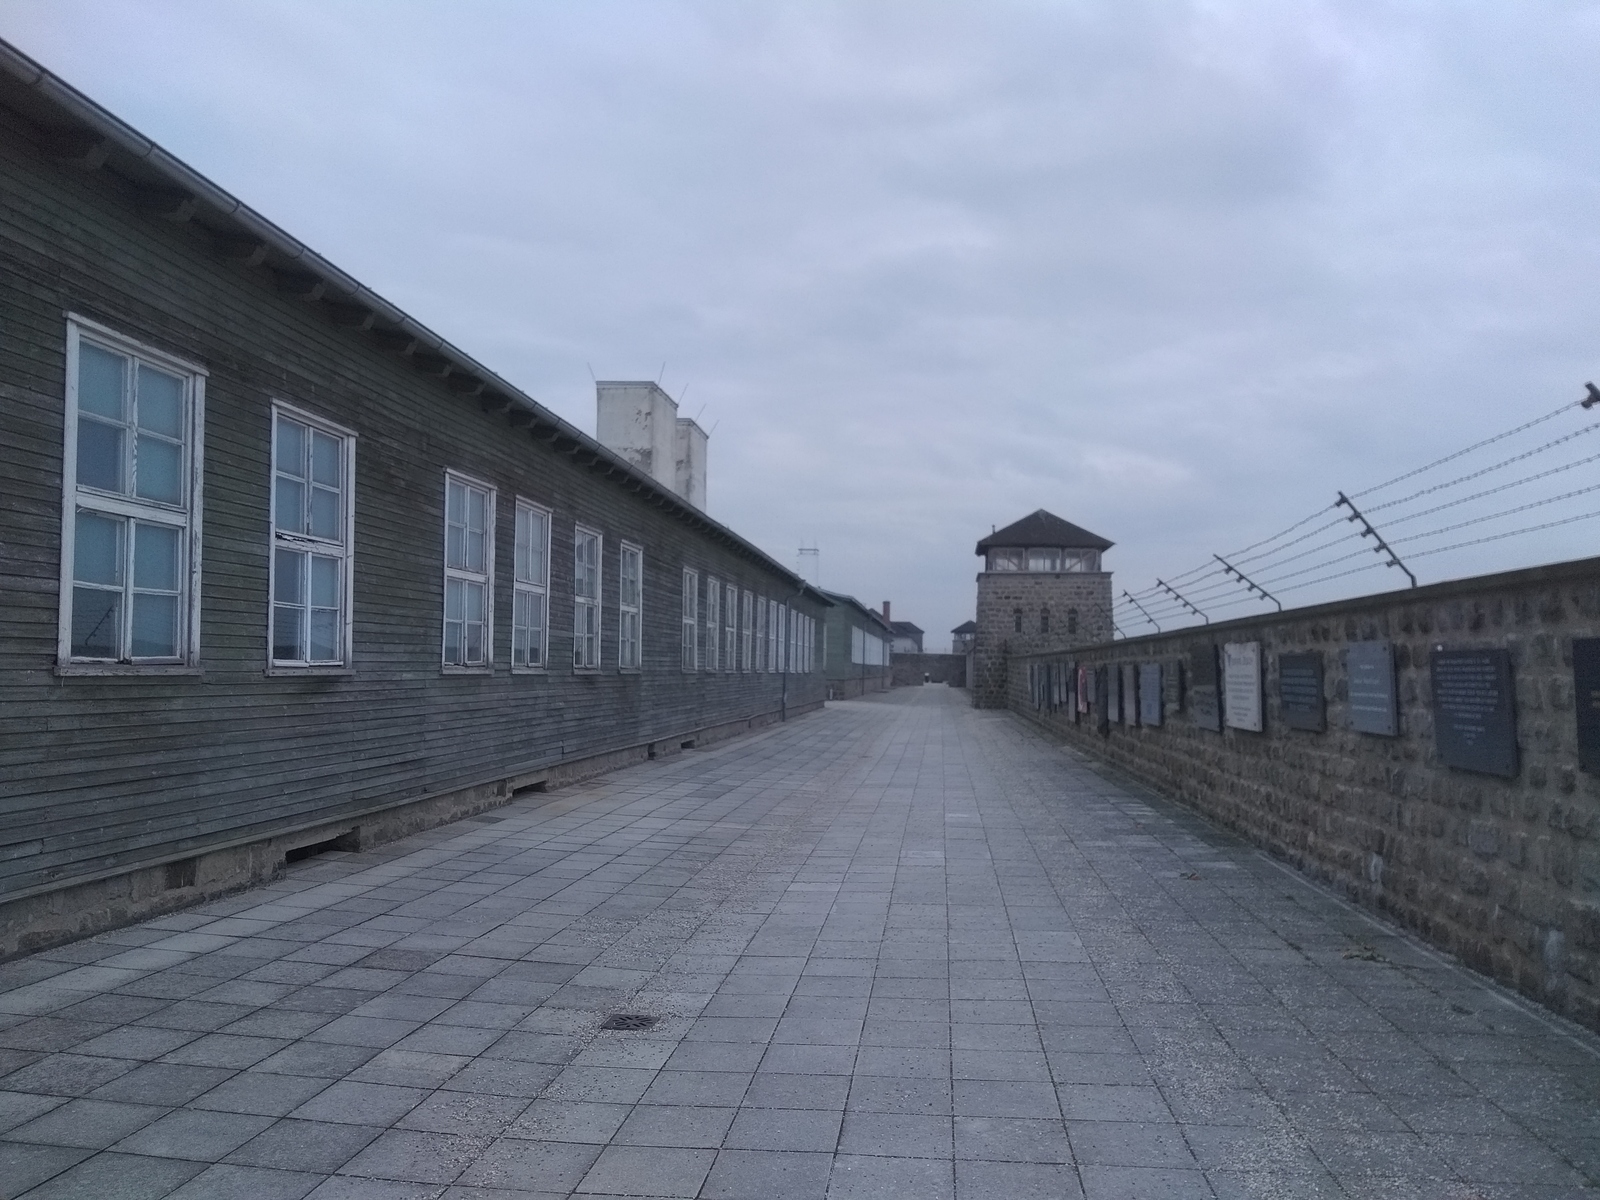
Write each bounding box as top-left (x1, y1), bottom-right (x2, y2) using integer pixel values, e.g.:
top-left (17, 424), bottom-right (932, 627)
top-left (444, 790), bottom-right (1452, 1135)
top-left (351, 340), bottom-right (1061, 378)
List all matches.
top-left (1112, 392), bottom-right (1600, 635)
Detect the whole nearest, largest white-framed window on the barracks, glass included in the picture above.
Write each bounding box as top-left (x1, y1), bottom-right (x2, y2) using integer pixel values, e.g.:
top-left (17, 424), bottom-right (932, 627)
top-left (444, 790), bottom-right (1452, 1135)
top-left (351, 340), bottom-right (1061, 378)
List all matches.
top-left (58, 318), bottom-right (205, 666)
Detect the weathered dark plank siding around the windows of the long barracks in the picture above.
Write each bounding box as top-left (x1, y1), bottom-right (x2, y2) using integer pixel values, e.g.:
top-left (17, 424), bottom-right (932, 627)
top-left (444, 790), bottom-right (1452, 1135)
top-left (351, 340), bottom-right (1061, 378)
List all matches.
top-left (0, 118), bottom-right (826, 902)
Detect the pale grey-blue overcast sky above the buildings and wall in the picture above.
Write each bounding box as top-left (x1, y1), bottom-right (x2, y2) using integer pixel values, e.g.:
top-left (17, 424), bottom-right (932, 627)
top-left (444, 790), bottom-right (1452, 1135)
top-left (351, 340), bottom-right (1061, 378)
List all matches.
top-left (0, 0), bottom-right (1600, 650)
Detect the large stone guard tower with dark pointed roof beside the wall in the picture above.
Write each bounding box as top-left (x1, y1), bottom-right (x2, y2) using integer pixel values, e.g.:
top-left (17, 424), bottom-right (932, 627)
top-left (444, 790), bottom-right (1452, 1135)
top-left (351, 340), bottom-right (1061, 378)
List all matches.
top-left (968, 509), bottom-right (1112, 709)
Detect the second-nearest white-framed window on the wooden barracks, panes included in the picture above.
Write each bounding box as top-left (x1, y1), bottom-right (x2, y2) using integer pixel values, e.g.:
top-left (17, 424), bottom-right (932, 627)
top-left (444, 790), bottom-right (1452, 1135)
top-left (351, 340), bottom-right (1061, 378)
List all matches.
top-left (270, 405), bottom-right (355, 667)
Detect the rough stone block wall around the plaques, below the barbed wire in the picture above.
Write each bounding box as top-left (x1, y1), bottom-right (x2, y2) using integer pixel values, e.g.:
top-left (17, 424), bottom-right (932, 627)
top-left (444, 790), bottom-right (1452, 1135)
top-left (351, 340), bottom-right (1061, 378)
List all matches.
top-left (1006, 558), bottom-right (1600, 1029)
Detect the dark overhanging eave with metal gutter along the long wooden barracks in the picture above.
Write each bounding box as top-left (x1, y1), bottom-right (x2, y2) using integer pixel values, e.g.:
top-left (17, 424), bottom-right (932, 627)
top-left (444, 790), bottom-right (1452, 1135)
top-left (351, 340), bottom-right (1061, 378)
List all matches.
top-left (0, 38), bottom-right (821, 598)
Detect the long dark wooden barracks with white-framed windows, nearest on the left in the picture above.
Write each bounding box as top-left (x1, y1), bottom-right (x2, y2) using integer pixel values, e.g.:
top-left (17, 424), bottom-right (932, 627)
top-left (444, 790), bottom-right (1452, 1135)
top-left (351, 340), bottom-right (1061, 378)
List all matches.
top-left (0, 43), bottom-right (829, 957)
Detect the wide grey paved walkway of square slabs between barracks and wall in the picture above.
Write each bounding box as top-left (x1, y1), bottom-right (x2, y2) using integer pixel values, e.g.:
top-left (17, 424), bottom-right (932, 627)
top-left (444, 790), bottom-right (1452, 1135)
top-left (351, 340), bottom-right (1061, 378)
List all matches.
top-left (0, 686), bottom-right (1600, 1200)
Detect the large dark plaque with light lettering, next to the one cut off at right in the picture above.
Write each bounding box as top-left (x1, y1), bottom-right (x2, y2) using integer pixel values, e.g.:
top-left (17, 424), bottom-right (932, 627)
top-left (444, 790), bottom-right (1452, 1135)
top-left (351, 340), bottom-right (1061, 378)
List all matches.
top-left (1429, 650), bottom-right (1517, 778)
